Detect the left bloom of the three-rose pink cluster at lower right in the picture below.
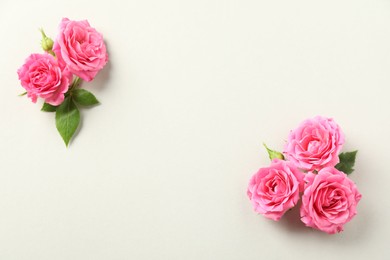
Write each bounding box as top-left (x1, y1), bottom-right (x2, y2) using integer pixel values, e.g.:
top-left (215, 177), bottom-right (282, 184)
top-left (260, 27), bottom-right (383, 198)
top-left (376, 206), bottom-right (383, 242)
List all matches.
top-left (247, 159), bottom-right (304, 221)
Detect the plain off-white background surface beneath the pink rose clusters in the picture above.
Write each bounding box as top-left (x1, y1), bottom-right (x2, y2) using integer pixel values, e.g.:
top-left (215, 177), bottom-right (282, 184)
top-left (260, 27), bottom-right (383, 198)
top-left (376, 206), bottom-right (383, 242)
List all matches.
top-left (0, 0), bottom-right (390, 260)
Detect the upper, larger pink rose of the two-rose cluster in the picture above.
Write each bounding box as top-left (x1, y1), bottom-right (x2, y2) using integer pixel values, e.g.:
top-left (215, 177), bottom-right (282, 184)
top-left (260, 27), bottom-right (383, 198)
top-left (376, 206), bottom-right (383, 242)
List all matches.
top-left (53, 18), bottom-right (108, 81)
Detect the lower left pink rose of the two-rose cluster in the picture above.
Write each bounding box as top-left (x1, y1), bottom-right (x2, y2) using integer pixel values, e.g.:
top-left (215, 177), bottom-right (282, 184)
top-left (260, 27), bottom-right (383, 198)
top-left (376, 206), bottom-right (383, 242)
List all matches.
top-left (18, 53), bottom-right (72, 106)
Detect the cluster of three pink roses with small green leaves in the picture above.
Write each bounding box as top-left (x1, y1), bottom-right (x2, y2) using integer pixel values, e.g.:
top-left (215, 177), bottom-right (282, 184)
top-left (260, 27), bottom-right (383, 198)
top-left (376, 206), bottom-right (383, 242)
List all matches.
top-left (247, 116), bottom-right (361, 234)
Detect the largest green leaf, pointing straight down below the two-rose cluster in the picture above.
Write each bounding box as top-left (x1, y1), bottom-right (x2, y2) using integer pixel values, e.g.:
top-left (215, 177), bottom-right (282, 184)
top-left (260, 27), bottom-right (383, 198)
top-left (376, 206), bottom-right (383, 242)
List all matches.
top-left (56, 96), bottom-right (80, 146)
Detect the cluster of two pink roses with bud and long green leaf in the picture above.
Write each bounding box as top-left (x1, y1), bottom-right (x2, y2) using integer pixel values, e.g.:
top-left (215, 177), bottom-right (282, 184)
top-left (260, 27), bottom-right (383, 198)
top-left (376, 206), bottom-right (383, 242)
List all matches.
top-left (18, 18), bottom-right (108, 146)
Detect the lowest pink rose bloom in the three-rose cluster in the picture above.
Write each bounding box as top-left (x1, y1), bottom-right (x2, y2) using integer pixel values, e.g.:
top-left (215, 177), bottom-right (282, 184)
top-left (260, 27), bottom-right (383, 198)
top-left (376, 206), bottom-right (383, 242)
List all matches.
top-left (300, 167), bottom-right (362, 234)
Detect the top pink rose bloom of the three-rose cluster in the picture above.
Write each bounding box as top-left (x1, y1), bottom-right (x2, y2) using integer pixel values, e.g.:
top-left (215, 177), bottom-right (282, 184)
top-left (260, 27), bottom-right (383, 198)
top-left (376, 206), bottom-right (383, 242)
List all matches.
top-left (284, 116), bottom-right (344, 171)
